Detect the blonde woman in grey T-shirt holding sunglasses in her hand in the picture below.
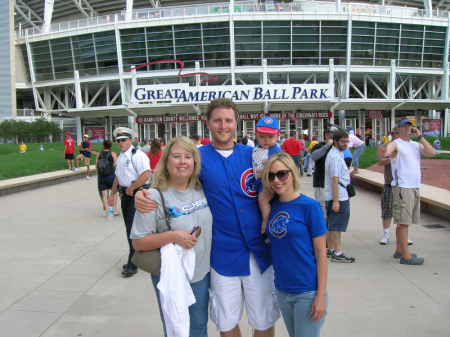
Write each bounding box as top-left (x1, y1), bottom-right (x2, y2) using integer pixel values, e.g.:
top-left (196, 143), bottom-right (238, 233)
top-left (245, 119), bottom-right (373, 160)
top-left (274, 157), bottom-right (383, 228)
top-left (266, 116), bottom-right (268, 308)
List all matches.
top-left (130, 136), bottom-right (212, 337)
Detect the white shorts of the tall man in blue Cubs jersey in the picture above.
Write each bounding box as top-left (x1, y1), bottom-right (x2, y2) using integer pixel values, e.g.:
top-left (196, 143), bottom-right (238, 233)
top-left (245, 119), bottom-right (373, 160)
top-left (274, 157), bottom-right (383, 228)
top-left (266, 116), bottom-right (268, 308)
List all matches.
top-left (209, 254), bottom-right (280, 332)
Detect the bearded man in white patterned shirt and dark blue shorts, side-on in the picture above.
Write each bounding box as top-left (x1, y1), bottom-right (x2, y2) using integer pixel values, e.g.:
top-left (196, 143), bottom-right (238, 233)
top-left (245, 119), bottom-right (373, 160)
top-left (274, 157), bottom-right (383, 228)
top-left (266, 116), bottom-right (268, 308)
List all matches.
top-left (325, 130), bottom-right (355, 263)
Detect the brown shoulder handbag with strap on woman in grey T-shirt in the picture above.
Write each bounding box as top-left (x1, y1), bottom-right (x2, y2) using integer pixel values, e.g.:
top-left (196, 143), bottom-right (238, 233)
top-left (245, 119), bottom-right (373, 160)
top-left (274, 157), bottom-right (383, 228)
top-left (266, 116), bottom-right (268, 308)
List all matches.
top-left (131, 186), bottom-right (172, 276)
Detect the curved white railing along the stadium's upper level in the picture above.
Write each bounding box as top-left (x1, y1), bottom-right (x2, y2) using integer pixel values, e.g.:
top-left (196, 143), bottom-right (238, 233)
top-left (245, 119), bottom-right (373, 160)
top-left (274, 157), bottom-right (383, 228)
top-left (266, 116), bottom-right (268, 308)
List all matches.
top-left (15, 1), bottom-right (449, 38)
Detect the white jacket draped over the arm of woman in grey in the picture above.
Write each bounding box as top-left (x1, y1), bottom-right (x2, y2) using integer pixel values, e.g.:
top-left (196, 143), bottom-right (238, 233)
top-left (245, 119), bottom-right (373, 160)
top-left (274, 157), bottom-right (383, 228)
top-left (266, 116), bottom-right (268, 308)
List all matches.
top-left (158, 243), bottom-right (195, 337)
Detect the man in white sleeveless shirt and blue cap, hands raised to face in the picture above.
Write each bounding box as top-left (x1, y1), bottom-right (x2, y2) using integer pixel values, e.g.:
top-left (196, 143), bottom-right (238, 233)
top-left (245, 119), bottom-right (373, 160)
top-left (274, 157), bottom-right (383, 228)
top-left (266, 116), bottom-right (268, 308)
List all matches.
top-left (377, 118), bottom-right (436, 265)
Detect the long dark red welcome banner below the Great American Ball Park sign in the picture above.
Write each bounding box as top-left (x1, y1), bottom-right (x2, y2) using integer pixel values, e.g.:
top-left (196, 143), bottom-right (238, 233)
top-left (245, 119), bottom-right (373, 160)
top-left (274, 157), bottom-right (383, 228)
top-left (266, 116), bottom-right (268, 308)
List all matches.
top-left (136, 112), bottom-right (332, 123)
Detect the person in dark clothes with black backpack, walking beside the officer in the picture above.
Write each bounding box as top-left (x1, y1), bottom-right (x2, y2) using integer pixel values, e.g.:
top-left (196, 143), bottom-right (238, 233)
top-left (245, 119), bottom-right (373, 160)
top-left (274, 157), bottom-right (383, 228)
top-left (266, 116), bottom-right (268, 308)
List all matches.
top-left (95, 140), bottom-right (119, 217)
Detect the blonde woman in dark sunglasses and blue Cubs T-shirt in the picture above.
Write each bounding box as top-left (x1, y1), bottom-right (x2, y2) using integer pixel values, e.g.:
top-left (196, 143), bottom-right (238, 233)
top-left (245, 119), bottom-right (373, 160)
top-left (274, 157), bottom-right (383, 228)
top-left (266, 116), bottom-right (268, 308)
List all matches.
top-left (262, 153), bottom-right (328, 337)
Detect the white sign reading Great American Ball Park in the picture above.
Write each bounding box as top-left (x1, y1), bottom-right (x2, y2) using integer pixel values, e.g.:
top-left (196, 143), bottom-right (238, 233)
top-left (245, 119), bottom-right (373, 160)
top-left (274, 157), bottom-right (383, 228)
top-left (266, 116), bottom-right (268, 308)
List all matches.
top-left (131, 83), bottom-right (334, 104)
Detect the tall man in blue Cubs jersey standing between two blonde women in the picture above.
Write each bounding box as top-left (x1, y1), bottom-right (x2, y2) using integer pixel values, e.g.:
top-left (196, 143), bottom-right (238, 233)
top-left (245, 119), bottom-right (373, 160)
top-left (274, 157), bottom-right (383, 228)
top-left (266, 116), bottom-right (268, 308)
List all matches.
top-left (136, 98), bottom-right (280, 337)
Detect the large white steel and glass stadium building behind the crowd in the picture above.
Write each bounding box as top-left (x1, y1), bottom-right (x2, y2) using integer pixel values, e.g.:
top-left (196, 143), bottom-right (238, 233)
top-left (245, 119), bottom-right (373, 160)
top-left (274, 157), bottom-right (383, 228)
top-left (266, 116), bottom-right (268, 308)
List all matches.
top-left (6, 0), bottom-right (450, 142)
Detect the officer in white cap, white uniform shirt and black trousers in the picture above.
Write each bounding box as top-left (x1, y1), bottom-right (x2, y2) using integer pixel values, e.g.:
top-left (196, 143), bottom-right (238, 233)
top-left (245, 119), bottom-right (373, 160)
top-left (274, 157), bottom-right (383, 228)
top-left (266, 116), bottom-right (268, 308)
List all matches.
top-left (108, 127), bottom-right (150, 277)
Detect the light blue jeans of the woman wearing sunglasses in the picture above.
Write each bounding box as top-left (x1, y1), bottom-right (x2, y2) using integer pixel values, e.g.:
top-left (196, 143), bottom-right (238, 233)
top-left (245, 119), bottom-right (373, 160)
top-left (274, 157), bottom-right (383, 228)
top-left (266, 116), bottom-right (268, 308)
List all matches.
top-left (275, 289), bottom-right (328, 337)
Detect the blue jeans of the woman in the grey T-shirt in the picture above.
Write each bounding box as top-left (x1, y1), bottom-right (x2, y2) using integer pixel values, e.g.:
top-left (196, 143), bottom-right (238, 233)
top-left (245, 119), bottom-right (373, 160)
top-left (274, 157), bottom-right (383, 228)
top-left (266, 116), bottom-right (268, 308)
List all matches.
top-left (151, 273), bottom-right (209, 337)
